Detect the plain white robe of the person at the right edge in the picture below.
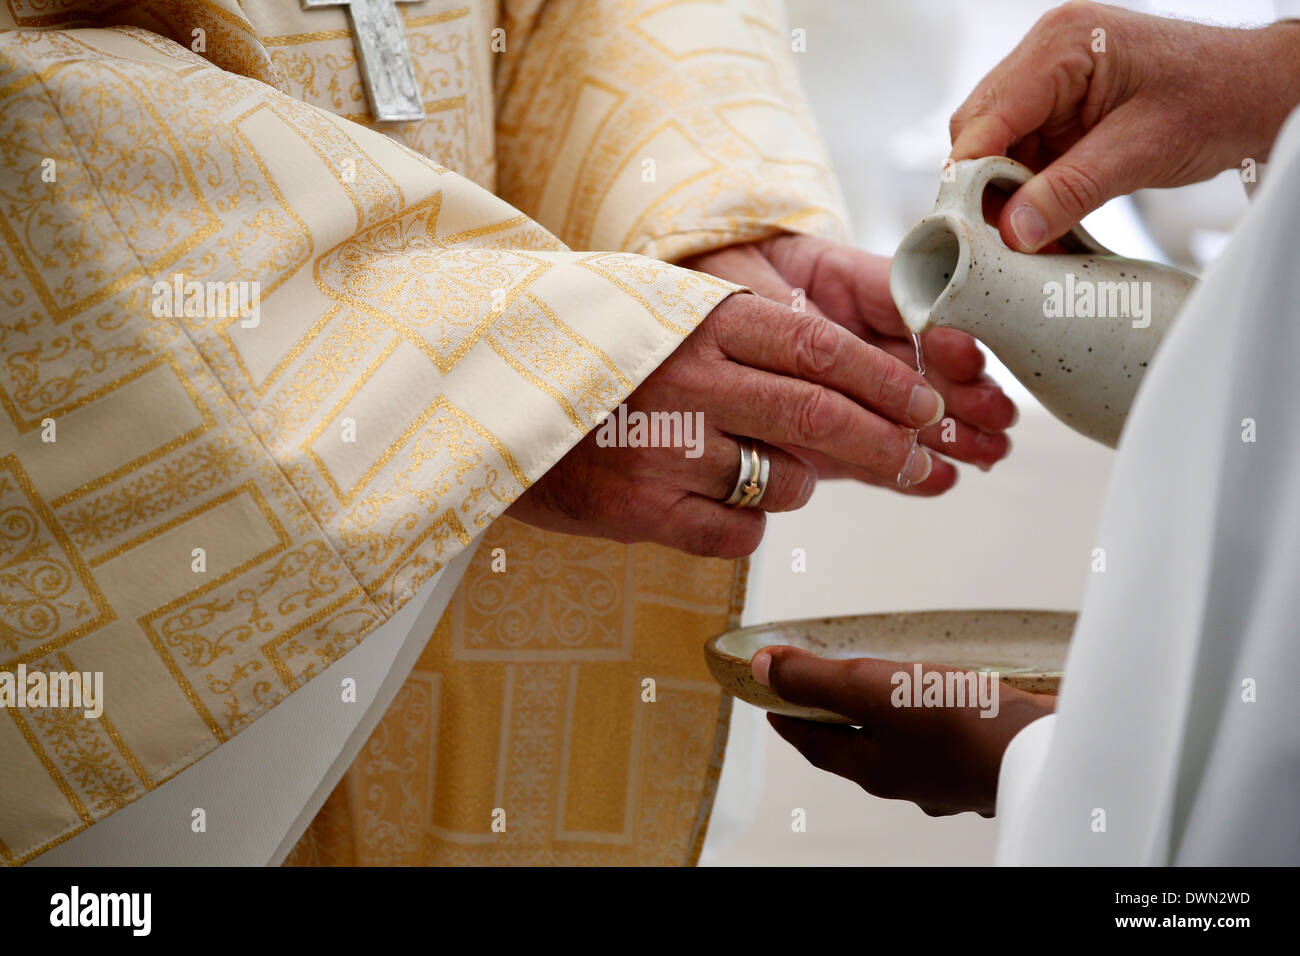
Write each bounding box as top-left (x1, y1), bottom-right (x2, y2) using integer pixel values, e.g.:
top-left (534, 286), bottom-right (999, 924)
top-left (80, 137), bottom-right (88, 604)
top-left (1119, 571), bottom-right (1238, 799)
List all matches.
top-left (997, 106), bottom-right (1300, 865)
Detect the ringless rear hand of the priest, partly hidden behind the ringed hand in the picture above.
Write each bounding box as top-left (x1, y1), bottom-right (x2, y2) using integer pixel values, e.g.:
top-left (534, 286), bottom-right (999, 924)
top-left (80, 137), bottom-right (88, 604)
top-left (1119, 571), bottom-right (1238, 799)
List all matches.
top-left (681, 235), bottom-right (1017, 494)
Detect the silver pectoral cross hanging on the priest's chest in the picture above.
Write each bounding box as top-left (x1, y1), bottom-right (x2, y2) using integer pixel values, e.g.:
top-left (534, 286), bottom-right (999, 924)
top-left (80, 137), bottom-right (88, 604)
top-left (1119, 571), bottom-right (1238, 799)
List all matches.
top-left (303, 0), bottom-right (424, 122)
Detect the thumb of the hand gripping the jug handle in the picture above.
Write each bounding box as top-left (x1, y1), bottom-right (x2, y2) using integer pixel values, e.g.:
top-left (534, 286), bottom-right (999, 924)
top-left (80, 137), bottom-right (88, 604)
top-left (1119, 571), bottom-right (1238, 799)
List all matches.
top-left (997, 112), bottom-right (1152, 252)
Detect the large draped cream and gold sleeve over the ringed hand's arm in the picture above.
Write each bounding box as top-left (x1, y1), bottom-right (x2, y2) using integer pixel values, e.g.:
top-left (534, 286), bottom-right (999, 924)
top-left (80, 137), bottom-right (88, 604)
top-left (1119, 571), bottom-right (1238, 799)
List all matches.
top-left (0, 26), bottom-right (733, 862)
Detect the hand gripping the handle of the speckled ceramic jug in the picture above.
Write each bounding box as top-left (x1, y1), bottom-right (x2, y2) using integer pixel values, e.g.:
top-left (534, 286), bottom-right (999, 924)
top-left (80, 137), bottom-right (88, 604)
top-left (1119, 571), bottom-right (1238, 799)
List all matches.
top-left (950, 3), bottom-right (1300, 252)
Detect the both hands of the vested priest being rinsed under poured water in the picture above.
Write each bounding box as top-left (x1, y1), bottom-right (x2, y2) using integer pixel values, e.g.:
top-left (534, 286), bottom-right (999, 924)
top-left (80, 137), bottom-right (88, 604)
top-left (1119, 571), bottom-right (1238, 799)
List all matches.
top-left (510, 235), bottom-right (1015, 558)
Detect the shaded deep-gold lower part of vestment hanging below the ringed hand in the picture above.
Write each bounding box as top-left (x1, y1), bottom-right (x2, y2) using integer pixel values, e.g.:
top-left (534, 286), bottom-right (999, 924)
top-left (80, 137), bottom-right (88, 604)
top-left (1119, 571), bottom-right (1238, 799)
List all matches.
top-left (289, 518), bottom-right (745, 866)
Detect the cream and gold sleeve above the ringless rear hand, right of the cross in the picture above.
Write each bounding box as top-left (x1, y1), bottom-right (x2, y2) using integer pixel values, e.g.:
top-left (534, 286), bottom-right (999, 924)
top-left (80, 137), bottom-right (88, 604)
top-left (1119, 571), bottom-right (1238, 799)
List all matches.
top-left (495, 0), bottom-right (846, 261)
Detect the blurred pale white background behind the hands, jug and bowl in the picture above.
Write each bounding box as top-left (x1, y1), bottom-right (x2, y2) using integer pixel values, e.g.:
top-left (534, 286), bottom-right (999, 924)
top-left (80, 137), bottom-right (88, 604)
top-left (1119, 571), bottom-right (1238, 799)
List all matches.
top-left (702, 0), bottom-right (1274, 865)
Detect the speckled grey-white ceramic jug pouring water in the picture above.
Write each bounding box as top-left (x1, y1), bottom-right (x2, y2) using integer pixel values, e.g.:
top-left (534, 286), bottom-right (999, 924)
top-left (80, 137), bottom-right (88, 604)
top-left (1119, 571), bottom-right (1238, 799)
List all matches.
top-left (889, 156), bottom-right (1196, 446)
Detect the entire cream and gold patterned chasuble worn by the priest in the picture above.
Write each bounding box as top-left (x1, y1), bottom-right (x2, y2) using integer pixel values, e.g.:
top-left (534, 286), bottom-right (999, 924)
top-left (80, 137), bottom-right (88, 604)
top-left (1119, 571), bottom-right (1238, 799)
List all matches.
top-left (0, 0), bottom-right (840, 864)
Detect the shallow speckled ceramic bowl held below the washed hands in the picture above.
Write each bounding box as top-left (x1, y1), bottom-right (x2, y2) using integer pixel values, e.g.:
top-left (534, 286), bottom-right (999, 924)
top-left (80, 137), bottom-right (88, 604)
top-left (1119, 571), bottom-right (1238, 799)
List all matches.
top-left (705, 610), bottom-right (1076, 723)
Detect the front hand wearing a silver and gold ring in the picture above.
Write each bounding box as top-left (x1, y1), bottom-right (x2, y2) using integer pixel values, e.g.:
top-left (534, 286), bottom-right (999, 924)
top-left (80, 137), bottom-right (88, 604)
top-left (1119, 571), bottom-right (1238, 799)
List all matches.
top-left (508, 294), bottom-right (952, 558)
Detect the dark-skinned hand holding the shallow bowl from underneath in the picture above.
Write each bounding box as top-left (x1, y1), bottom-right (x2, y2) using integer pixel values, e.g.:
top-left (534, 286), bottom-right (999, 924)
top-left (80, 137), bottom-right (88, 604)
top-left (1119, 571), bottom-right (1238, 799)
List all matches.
top-left (753, 646), bottom-right (1056, 817)
